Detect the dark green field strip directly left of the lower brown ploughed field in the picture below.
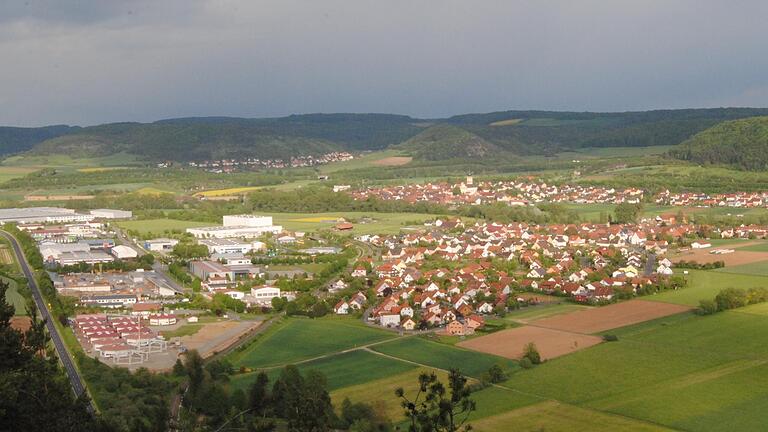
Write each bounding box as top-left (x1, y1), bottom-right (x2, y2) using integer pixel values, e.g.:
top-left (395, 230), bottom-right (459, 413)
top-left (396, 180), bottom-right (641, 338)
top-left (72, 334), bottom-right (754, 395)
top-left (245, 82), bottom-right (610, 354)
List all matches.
top-left (371, 337), bottom-right (518, 378)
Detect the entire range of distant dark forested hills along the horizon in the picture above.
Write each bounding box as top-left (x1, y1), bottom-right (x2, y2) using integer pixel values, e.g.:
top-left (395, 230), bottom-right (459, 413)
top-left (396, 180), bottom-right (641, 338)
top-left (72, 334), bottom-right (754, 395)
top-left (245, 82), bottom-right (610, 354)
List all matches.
top-left (0, 108), bottom-right (768, 161)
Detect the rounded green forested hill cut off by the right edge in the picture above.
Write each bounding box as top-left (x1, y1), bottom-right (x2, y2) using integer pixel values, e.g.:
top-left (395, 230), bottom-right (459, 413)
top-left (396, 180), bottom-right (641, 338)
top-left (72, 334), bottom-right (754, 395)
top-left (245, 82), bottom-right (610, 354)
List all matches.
top-left (671, 116), bottom-right (768, 171)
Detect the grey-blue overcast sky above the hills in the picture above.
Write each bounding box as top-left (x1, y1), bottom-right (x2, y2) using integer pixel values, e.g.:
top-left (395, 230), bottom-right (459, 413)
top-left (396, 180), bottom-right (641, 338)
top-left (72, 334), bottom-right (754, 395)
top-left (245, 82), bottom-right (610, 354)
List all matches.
top-left (0, 0), bottom-right (768, 126)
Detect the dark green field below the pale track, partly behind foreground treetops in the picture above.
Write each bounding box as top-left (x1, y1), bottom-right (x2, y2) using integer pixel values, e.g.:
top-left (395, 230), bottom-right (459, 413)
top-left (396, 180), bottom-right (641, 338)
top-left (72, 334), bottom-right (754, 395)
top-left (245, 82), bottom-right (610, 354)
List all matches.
top-left (231, 349), bottom-right (417, 391)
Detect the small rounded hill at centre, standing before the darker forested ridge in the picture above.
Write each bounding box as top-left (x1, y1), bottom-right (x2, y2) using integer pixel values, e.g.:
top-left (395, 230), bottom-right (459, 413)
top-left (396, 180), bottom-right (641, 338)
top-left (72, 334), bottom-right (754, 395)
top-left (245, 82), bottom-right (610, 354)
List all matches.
top-left (394, 124), bottom-right (502, 160)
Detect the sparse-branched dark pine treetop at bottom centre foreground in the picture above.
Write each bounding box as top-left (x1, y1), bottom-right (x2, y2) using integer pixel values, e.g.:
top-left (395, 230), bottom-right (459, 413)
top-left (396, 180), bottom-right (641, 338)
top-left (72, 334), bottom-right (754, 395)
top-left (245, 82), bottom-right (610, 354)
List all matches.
top-left (395, 369), bottom-right (476, 432)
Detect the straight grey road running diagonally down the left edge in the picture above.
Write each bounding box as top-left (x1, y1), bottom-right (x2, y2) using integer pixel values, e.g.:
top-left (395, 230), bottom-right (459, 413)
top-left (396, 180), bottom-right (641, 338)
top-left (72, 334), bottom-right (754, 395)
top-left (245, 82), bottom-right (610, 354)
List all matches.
top-left (0, 231), bottom-right (94, 412)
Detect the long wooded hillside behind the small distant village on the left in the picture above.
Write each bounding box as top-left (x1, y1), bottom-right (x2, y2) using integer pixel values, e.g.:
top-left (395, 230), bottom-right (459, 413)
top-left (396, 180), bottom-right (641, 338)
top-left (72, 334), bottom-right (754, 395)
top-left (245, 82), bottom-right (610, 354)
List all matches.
top-left (27, 114), bottom-right (421, 161)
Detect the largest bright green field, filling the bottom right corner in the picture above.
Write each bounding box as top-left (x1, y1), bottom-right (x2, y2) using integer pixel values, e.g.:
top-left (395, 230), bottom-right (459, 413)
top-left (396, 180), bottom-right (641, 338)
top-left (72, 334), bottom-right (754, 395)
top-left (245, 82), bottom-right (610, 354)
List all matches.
top-left (503, 310), bottom-right (768, 431)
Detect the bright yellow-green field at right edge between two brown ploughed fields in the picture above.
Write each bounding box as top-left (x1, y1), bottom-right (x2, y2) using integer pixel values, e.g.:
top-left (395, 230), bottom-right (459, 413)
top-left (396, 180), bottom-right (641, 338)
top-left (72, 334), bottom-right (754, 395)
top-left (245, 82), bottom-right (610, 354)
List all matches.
top-left (643, 266), bottom-right (768, 306)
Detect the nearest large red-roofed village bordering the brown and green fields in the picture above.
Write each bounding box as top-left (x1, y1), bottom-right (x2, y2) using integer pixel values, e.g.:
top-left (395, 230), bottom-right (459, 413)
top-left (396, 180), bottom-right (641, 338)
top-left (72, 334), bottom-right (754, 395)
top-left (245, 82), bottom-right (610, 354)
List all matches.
top-left (346, 216), bottom-right (766, 336)
